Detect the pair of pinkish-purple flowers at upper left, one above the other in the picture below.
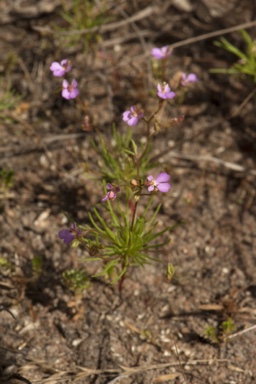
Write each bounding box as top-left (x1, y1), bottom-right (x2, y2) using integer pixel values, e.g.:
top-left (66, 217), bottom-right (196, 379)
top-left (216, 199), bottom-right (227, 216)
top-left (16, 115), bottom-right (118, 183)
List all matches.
top-left (50, 59), bottom-right (79, 100)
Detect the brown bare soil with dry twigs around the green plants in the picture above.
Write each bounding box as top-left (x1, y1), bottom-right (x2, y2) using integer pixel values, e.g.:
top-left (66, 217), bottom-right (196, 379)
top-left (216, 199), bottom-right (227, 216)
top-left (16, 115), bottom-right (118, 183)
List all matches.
top-left (0, 0), bottom-right (256, 384)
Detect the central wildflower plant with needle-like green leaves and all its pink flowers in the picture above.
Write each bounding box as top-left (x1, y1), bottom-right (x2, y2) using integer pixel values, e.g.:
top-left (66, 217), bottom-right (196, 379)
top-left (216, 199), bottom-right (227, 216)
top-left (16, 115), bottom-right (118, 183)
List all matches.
top-left (50, 42), bottom-right (197, 290)
